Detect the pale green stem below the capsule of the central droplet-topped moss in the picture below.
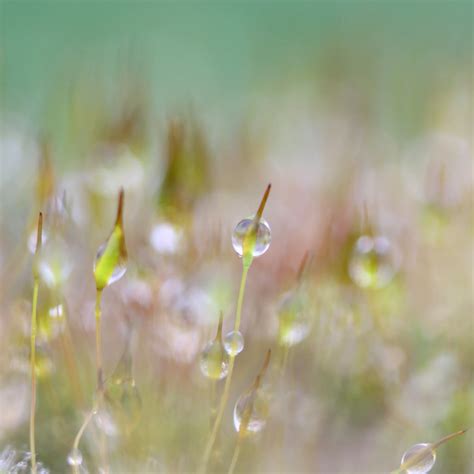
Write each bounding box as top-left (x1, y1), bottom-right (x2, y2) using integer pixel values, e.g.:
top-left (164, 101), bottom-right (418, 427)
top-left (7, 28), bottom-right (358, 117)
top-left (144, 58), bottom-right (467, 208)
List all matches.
top-left (199, 265), bottom-right (250, 474)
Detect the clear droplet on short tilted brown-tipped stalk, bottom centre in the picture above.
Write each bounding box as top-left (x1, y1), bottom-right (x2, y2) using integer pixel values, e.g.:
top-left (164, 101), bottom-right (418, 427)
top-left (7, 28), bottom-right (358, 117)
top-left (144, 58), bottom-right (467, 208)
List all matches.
top-left (234, 389), bottom-right (269, 434)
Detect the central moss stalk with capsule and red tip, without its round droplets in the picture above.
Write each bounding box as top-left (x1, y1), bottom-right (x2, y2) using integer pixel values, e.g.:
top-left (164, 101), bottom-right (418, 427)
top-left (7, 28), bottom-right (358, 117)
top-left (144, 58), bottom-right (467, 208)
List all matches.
top-left (199, 184), bottom-right (272, 474)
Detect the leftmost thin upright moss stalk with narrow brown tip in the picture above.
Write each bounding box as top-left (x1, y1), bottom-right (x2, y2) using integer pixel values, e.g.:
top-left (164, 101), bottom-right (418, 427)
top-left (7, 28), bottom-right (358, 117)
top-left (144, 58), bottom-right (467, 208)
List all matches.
top-left (30, 212), bottom-right (43, 474)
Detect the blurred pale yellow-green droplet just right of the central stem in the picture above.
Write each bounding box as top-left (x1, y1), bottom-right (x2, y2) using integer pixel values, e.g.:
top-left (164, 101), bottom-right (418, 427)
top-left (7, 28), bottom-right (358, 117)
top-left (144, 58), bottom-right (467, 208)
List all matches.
top-left (278, 289), bottom-right (312, 346)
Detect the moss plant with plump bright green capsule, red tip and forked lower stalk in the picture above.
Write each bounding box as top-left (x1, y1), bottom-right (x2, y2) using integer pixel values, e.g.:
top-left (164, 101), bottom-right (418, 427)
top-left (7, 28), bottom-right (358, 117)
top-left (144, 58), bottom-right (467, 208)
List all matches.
top-left (68, 189), bottom-right (127, 473)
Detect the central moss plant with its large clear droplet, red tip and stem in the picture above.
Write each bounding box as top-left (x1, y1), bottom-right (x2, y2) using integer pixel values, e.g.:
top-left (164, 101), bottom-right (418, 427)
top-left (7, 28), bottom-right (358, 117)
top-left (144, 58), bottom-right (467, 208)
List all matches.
top-left (199, 184), bottom-right (271, 473)
